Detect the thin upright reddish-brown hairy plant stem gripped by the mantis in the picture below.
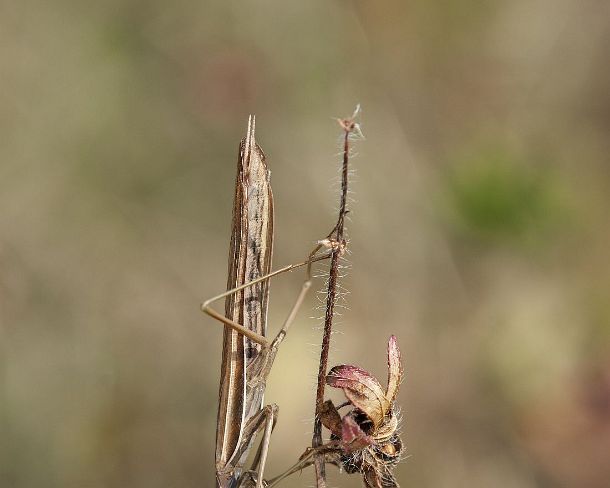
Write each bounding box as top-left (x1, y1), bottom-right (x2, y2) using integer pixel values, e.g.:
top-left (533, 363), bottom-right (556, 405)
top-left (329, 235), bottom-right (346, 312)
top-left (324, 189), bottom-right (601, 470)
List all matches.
top-left (312, 119), bottom-right (356, 488)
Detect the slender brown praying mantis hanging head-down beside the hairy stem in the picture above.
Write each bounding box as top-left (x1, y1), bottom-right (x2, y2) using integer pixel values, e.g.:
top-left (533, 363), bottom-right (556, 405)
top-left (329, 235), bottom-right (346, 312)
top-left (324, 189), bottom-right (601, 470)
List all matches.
top-left (201, 116), bottom-right (334, 488)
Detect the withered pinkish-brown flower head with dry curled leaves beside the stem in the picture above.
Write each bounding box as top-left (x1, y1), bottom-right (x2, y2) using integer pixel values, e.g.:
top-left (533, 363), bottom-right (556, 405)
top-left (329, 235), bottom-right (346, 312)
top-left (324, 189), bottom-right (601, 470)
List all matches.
top-left (322, 336), bottom-right (403, 488)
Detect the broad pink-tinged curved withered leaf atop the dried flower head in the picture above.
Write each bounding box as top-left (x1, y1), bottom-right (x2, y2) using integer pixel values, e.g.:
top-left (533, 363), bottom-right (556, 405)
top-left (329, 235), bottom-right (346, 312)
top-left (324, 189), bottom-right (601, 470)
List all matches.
top-left (326, 364), bottom-right (391, 428)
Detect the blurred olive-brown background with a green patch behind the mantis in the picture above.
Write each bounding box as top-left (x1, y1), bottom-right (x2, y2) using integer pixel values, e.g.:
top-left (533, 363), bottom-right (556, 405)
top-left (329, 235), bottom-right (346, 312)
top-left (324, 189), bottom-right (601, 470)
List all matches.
top-left (0, 0), bottom-right (610, 488)
